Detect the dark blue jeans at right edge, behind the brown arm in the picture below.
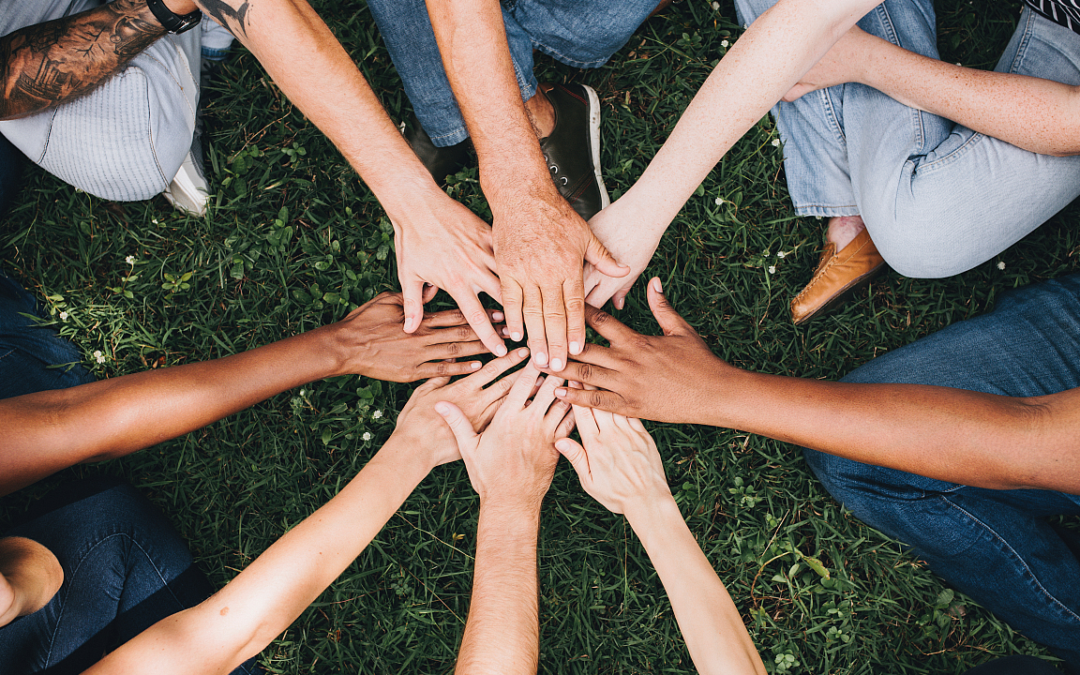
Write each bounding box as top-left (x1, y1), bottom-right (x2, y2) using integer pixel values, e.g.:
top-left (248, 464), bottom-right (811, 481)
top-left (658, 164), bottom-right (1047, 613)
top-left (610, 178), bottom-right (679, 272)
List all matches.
top-left (806, 274), bottom-right (1080, 672)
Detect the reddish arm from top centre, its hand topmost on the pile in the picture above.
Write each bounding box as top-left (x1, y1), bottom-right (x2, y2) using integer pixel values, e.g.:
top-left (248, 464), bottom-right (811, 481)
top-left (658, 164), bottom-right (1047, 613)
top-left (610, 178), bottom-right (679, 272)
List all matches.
top-left (419, 0), bottom-right (625, 370)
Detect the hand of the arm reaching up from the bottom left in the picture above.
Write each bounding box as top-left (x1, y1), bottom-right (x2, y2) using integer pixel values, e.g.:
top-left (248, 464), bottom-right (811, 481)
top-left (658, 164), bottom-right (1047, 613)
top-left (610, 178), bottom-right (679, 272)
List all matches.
top-left (393, 347), bottom-right (536, 469)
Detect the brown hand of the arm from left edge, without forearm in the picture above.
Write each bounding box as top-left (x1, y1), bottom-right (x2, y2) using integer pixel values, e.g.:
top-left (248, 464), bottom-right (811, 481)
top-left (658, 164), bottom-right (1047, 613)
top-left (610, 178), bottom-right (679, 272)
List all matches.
top-left (319, 293), bottom-right (502, 382)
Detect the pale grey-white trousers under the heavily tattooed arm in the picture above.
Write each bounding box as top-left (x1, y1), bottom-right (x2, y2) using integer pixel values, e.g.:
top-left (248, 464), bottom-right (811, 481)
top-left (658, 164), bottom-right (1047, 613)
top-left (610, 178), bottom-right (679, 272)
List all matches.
top-left (0, 0), bottom-right (220, 201)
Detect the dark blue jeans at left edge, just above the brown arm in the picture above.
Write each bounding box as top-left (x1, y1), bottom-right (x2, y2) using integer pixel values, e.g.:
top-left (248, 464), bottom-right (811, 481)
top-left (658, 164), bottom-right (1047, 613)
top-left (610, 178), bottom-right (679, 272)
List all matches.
top-left (0, 272), bottom-right (94, 399)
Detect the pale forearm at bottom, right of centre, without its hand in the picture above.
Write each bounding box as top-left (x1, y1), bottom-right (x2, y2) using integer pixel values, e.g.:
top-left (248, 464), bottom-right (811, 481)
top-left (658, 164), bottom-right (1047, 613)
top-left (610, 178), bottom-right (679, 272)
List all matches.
top-left (626, 495), bottom-right (766, 675)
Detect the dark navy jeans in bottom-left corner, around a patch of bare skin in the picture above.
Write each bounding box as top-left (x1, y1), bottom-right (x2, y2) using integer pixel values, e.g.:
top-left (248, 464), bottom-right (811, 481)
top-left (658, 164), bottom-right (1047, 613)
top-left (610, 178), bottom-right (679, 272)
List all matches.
top-left (0, 481), bottom-right (260, 675)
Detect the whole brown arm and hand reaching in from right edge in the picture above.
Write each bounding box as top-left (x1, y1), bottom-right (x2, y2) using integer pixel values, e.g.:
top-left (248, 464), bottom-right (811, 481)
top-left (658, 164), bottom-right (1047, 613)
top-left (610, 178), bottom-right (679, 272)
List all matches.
top-left (556, 279), bottom-right (1080, 494)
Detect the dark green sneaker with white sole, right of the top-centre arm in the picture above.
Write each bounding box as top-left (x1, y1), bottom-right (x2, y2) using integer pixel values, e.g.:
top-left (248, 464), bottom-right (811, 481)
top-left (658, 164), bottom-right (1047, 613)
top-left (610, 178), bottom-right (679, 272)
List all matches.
top-left (539, 84), bottom-right (611, 220)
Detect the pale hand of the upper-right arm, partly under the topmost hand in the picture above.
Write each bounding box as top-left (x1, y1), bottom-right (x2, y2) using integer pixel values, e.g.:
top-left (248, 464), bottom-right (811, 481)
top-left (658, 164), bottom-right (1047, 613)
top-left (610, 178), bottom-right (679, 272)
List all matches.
top-left (584, 199), bottom-right (663, 309)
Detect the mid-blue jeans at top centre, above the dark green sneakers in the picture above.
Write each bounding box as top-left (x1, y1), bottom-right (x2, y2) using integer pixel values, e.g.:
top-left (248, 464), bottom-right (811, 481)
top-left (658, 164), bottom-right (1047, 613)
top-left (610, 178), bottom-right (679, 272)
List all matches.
top-left (367, 0), bottom-right (660, 148)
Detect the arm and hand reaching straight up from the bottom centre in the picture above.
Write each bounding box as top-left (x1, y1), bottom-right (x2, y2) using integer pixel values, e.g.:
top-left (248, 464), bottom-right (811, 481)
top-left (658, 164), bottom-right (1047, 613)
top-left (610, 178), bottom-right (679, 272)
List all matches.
top-left (436, 364), bottom-right (573, 675)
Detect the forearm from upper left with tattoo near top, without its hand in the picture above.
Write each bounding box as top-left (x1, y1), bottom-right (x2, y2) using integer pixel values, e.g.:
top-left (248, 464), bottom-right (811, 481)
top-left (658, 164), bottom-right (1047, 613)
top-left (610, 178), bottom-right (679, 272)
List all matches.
top-left (199, 0), bottom-right (447, 219)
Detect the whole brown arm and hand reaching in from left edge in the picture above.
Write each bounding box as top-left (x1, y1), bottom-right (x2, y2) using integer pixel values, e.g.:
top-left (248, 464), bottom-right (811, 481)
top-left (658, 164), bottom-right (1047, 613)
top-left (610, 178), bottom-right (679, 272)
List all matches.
top-left (0, 294), bottom-right (484, 495)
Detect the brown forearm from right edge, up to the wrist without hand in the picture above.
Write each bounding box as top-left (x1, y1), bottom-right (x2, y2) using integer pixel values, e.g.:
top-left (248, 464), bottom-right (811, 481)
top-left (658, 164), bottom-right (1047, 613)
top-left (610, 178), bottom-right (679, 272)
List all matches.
top-left (700, 366), bottom-right (1080, 494)
